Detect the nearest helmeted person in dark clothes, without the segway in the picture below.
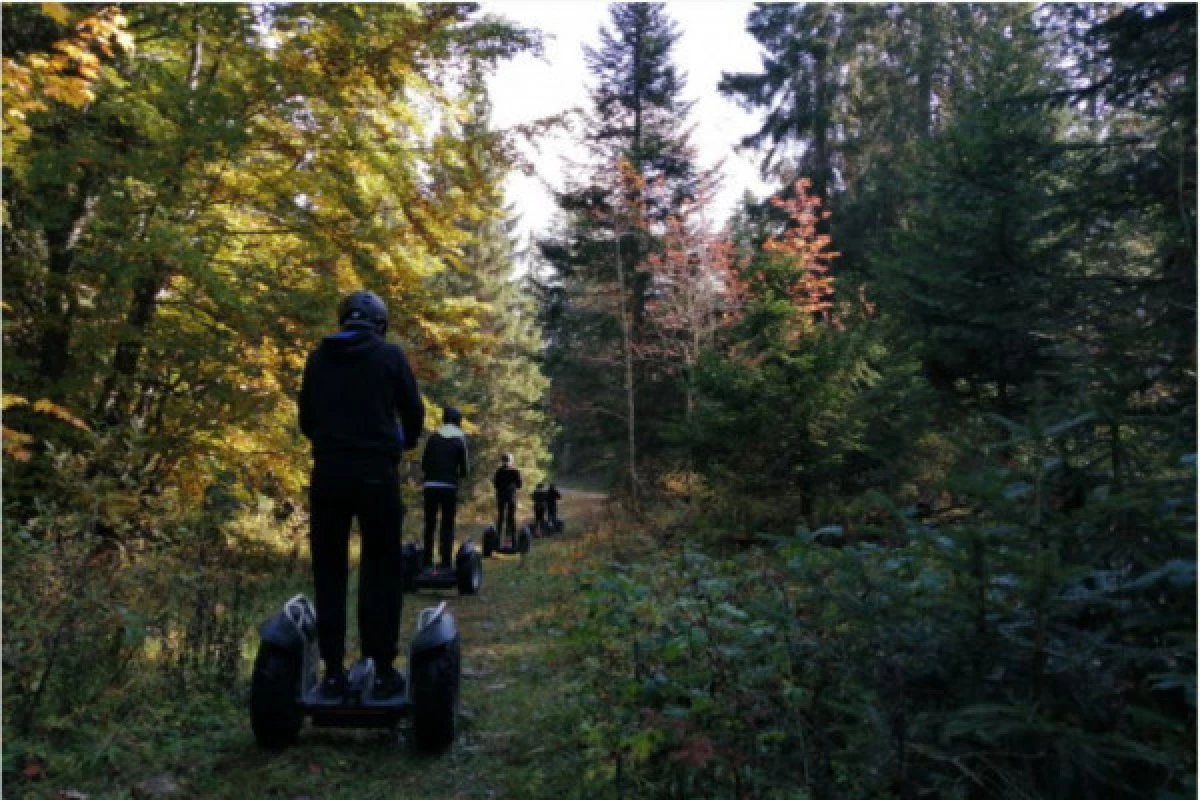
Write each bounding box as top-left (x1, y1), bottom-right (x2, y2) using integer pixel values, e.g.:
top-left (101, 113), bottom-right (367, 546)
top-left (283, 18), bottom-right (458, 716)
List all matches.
top-left (299, 291), bottom-right (425, 697)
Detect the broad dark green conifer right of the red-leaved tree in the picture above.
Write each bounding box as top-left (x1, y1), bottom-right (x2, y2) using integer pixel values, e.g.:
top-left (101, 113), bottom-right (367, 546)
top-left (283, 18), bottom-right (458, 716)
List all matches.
top-left (874, 14), bottom-right (1070, 414)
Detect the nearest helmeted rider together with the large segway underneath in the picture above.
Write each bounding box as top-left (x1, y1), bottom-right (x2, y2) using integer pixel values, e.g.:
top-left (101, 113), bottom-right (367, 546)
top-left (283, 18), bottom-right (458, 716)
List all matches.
top-left (250, 291), bottom-right (462, 752)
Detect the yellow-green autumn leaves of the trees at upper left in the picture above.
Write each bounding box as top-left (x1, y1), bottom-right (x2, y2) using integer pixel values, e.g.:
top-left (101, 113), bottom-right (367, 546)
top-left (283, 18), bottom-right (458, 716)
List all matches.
top-left (4, 5), bottom-right (532, 506)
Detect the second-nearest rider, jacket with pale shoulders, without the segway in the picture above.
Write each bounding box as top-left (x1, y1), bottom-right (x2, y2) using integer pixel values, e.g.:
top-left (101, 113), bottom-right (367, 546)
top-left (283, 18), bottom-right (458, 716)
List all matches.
top-left (421, 407), bottom-right (469, 570)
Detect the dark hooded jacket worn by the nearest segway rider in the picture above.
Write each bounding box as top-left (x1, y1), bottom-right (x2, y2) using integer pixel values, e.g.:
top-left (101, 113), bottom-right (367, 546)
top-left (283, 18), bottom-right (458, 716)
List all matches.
top-left (300, 327), bottom-right (425, 463)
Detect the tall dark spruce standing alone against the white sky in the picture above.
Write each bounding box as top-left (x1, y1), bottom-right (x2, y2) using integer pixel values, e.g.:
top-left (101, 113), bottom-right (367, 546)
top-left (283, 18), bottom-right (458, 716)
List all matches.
top-left (540, 4), bottom-right (713, 492)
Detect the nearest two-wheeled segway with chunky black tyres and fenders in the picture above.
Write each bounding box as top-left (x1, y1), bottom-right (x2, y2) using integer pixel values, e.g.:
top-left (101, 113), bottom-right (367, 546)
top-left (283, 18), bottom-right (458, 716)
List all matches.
top-left (250, 595), bottom-right (461, 752)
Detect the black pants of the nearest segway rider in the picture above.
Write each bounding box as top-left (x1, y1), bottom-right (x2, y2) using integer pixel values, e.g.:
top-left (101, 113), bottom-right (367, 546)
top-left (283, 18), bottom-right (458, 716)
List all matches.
top-left (308, 462), bottom-right (404, 669)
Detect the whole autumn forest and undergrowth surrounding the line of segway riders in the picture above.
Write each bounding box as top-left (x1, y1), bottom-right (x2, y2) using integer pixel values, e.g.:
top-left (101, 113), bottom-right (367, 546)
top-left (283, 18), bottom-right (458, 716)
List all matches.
top-left (2, 2), bottom-right (1198, 800)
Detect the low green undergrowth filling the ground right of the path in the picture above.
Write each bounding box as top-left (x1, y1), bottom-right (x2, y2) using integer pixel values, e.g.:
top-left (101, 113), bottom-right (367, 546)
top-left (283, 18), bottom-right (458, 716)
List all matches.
top-left (572, 422), bottom-right (1195, 798)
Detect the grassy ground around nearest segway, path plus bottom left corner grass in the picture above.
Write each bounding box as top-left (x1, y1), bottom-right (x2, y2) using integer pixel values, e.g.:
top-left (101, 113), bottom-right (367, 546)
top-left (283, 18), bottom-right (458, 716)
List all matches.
top-left (21, 492), bottom-right (605, 800)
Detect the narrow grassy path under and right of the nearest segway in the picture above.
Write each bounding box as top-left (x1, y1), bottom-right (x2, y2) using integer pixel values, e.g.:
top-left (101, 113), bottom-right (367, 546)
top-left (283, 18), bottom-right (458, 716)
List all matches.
top-left (186, 491), bottom-right (606, 800)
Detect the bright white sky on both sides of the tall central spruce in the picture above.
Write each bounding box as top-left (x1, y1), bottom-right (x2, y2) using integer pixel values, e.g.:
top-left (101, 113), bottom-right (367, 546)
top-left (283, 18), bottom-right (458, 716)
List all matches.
top-left (481, 0), bottom-right (768, 253)
